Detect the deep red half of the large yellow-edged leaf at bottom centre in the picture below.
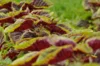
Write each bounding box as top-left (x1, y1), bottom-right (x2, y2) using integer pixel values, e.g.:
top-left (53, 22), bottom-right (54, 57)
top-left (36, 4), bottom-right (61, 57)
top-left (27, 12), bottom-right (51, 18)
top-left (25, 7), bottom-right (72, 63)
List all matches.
top-left (48, 47), bottom-right (73, 64)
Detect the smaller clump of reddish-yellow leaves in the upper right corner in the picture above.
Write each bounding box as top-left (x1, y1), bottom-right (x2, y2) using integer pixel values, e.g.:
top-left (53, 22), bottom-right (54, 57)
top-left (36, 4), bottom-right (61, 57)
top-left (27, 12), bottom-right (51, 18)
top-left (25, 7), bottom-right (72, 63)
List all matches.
top-left (84, 0), bottom-right (100, 31)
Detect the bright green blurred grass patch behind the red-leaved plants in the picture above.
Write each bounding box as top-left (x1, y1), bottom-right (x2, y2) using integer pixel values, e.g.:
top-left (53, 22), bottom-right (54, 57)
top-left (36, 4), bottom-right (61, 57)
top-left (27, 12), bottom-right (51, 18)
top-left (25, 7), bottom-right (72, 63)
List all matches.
top-left (50, 0), bottom-right (91, 21)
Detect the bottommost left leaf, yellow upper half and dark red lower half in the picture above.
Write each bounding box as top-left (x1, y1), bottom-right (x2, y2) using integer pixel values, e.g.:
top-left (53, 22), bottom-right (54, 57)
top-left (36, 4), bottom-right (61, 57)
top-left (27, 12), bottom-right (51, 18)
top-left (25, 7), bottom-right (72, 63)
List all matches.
top-left (10, 52), bottom-right (39, 66)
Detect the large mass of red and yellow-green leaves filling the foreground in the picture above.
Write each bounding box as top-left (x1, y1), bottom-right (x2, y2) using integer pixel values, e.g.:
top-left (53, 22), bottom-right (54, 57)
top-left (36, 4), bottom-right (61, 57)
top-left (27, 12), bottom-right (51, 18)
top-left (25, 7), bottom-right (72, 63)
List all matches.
top-left (0, 0), bottom-right (100, 66)
